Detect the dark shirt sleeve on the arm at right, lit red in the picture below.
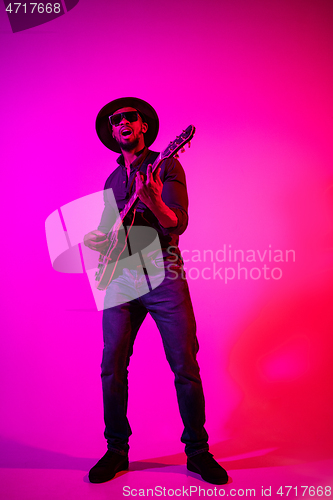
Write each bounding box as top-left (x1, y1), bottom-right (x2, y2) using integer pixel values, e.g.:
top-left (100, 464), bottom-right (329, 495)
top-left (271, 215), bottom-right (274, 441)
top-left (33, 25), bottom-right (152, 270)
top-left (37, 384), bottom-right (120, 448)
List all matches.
top-left (160, 158), bottom-right (188, 235)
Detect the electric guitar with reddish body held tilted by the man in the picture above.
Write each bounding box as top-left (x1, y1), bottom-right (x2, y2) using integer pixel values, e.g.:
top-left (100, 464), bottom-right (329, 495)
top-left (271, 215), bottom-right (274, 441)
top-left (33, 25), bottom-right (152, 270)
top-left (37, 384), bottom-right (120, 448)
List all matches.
top-left (95, 125), bottom-right (195, 290)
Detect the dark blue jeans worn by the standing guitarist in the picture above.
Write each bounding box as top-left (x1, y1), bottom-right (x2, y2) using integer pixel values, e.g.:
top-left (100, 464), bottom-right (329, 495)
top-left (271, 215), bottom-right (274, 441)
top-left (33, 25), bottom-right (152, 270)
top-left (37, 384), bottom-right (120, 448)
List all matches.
top-left (102, 266), bottom-right (208, 456)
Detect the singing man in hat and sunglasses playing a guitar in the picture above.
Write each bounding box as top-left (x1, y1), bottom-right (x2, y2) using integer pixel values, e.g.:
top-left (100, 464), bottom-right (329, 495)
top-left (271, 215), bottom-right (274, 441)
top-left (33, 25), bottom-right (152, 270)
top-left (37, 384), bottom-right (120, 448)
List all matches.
top-left (85, 98), bottom-right (228, 484)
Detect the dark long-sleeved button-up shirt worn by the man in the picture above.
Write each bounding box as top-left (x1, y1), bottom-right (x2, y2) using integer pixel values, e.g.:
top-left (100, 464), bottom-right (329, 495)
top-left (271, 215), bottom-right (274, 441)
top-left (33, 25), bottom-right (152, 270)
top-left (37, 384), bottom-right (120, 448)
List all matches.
top-left (98, 148), bottom-right (188, 256)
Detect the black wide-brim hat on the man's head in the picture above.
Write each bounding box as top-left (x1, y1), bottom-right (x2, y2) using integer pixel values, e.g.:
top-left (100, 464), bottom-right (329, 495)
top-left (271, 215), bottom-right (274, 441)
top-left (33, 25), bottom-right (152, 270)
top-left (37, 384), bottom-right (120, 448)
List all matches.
top-left (96, 97), bottom-right (159, 153)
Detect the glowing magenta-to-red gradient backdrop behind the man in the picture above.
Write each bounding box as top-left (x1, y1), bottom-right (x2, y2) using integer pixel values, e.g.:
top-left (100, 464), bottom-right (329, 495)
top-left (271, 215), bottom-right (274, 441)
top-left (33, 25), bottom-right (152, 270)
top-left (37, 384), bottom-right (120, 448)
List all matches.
top-left (0, 0), bottom-right (333, 480)
